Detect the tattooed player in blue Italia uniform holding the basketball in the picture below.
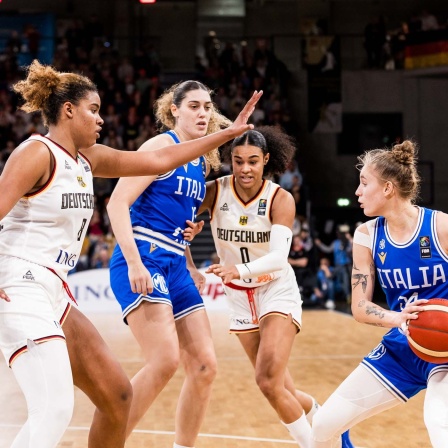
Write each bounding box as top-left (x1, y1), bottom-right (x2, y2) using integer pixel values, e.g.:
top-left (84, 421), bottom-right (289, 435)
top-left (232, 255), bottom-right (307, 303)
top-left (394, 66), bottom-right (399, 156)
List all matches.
top-left (313, 140), bottom-right (448, 448)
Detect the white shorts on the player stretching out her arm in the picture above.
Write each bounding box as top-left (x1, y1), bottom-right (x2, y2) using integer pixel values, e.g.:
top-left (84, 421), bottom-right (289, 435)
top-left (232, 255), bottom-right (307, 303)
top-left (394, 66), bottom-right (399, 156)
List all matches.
top-left (0, 255), bottom-right (71, 365)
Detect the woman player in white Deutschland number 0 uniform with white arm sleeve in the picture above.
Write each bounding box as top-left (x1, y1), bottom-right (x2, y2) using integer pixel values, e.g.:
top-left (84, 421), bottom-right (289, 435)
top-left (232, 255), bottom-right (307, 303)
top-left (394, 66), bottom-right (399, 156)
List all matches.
top-left (190, 127), bottom-right (351, 448)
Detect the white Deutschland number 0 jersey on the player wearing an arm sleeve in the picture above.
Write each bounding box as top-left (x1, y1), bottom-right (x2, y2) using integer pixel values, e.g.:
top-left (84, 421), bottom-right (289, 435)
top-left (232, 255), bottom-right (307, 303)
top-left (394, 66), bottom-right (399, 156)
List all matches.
top-left (210, 175), bottom-right (284, 288)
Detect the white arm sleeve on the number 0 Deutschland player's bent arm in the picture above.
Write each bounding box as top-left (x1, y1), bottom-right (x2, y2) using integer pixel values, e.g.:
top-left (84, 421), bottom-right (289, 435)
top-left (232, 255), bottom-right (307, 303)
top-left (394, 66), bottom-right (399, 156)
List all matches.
top-left (236, 224), bottom-right (292, 280)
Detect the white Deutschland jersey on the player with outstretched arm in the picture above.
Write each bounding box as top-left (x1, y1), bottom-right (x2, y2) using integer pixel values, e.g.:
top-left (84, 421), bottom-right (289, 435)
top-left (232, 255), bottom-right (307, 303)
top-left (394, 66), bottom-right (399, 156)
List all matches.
top-left (0, 135), bottom-right (94, 280)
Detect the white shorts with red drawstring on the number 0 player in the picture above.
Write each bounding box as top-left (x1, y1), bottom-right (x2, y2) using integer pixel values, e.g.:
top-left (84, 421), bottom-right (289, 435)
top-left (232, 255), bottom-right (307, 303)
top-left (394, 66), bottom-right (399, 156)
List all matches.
top-left (224, 269), bottom-right (302, 333)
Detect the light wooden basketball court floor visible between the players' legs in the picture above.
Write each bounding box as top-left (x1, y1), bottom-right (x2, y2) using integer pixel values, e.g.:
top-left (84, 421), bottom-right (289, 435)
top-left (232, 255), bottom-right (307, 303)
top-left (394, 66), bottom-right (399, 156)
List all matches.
top-left (0, 309), bottom-right (431, 448)
